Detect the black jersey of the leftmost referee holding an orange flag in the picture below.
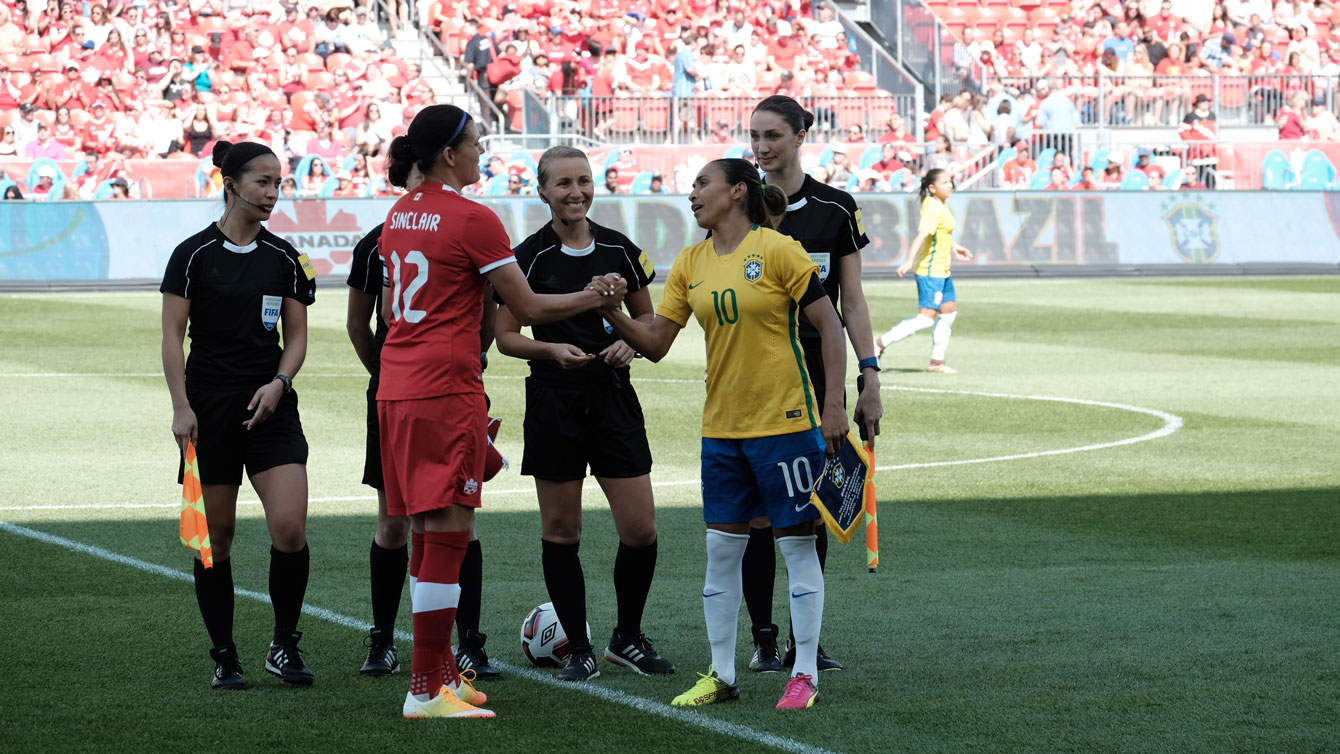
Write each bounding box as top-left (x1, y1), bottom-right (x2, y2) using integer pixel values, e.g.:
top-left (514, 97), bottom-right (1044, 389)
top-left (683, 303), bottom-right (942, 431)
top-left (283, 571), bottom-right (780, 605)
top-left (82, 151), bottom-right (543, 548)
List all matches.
top-left (158, 222), bottom-right (316, 387)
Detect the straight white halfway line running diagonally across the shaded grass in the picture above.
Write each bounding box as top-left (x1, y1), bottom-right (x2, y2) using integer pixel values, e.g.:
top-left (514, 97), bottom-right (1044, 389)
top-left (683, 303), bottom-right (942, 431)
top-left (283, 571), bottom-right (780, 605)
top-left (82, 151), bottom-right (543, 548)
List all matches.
top-left (0, 521), bottom-right (835, 754)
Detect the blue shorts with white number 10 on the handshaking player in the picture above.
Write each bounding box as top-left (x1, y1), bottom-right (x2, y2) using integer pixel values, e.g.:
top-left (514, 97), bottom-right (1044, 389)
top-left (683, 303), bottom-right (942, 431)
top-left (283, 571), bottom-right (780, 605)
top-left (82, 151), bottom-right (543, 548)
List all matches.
top-left (702, 429), bottom-right (825, 529)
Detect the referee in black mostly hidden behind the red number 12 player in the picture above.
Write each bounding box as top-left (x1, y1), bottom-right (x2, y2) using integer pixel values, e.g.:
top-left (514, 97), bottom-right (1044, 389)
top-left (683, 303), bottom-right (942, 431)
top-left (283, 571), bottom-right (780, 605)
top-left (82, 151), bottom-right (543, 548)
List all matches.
top-left (344, 162), bottom-right (501, 680)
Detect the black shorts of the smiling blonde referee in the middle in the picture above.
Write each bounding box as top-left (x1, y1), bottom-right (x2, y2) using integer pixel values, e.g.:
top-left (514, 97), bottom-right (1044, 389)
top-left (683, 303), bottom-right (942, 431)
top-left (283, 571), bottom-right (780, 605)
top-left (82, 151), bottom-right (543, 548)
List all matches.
top-left (521, 370), bottom-right (651, 482)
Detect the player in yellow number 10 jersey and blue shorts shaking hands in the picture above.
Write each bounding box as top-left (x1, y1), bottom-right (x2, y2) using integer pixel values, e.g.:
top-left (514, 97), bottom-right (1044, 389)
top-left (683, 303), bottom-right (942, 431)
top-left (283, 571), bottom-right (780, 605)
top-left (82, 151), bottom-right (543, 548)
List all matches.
top-left (606, 159), bottom-right (847, 708)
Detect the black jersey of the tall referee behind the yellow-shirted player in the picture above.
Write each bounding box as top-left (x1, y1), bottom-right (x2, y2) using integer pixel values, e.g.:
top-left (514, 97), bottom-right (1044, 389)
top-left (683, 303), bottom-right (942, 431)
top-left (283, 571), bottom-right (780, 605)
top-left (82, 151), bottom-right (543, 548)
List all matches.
top-left (777, 175), bottom-right (870, 346)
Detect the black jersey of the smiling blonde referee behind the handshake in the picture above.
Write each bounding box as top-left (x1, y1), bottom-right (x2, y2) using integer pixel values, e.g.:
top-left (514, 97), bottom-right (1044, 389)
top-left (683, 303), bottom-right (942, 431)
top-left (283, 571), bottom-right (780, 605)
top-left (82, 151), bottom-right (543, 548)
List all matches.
top-left (498, 220), bottom-right (657, 378)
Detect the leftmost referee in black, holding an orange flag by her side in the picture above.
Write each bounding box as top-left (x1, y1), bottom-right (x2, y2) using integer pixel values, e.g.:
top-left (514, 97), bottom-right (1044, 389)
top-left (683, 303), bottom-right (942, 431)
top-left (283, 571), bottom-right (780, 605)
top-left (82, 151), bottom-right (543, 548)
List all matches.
top-left (159, 142), bottom-right (316, 688)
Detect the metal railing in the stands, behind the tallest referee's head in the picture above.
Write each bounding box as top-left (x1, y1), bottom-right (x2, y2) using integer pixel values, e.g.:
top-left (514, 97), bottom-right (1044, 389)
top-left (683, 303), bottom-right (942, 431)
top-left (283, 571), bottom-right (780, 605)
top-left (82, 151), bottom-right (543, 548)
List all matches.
top-left (536, 94), bottom-right (917, 146)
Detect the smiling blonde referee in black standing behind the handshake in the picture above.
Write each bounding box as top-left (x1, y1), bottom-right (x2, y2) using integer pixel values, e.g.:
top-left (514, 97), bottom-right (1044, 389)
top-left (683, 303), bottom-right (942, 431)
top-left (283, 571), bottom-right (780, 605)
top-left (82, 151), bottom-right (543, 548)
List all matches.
top-left (497, 146), bottom-right (674, 680)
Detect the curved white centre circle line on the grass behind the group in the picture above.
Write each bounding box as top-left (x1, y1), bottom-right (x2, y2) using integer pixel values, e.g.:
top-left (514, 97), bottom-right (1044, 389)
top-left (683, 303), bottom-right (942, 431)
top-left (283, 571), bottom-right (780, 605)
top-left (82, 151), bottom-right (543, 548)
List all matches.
top-left (0, 375), bottom-right (1182, 512)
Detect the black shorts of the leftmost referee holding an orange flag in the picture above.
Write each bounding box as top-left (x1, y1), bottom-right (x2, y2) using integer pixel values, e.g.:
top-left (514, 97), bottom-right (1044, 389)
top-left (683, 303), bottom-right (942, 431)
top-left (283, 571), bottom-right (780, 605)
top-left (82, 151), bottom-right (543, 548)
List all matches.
top-left (177, 384), bottom-right (307, 485)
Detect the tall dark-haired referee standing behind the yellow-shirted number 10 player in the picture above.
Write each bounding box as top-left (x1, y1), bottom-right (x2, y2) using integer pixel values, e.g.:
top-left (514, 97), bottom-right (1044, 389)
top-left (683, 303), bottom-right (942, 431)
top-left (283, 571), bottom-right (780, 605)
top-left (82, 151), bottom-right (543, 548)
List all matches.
top-left (745, 95), bottom-right (884, 672)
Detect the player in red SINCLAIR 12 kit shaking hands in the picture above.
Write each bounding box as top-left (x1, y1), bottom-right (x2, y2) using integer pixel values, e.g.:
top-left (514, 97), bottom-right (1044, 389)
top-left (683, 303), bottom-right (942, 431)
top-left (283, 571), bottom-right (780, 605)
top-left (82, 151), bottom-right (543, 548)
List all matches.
top-left (377, 104), bottom-right (627, 718)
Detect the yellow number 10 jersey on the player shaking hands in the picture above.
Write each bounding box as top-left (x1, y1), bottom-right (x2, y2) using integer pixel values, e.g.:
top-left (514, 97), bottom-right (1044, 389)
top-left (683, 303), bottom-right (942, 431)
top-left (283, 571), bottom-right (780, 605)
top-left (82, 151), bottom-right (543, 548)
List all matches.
top-left (657, 226), bottom-right (820, 439)
